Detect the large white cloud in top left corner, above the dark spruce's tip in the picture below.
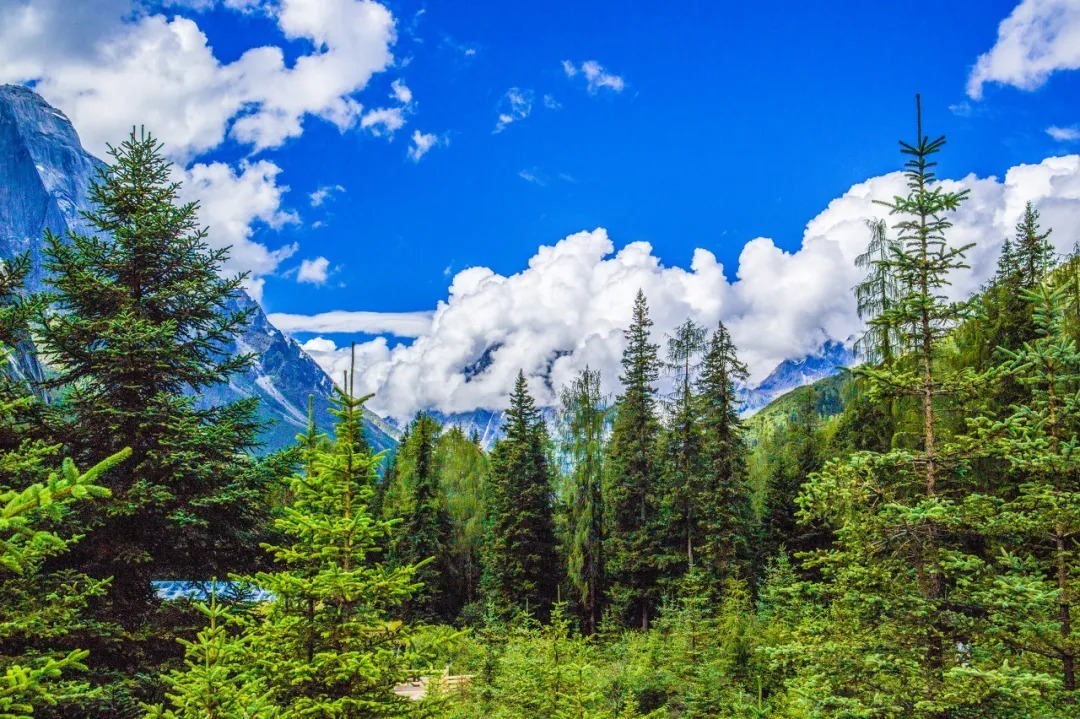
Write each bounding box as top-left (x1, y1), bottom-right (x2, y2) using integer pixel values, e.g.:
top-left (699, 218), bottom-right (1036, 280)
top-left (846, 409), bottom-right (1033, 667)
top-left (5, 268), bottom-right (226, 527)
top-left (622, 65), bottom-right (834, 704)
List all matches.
top-left (0, 0), bottom-right (395, 161)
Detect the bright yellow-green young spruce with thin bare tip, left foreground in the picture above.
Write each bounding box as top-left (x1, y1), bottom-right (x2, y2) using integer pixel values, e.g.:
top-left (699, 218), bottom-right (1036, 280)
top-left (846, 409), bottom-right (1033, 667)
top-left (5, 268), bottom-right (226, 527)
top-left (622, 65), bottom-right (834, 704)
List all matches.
top-left (243, 364), bottom-right (427, 719)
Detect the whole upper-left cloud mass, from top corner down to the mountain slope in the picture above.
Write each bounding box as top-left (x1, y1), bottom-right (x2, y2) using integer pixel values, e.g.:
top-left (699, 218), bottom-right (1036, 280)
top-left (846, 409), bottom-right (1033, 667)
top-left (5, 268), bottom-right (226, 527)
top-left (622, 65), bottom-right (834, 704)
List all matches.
top-left (0, 0), bottom-right (413, 299)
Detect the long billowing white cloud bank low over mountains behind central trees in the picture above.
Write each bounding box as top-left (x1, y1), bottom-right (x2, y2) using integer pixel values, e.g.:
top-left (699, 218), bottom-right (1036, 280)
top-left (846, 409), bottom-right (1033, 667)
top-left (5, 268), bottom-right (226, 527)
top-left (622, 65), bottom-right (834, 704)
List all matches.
top-left (280, 154), bottom-right (1080, 418)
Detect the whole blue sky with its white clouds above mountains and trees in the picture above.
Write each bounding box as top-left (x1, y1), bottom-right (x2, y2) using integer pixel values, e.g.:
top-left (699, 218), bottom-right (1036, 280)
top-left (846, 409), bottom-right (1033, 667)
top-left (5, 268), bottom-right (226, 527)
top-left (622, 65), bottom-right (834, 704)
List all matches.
top-left (0, 0), bottom-right (1080, 413)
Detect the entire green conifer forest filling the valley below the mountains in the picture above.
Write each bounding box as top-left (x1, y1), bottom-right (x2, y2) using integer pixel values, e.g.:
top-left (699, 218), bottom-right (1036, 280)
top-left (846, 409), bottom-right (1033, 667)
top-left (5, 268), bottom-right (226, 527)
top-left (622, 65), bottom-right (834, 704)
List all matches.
top-left (0, 102), bottom-right (1080, 719)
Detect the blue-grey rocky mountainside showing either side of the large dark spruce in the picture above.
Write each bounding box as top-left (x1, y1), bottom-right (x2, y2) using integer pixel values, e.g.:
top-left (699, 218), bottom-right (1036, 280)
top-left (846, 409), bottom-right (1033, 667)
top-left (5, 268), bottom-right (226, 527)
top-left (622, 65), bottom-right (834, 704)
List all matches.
top-left (0, 85), bottom-right (396, 450)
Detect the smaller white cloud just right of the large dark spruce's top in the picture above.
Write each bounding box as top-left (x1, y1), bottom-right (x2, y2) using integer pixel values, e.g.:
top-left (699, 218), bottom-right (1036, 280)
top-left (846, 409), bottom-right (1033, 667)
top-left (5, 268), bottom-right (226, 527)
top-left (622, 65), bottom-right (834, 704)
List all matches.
top-left (174, 160), bottom-right (299, 300)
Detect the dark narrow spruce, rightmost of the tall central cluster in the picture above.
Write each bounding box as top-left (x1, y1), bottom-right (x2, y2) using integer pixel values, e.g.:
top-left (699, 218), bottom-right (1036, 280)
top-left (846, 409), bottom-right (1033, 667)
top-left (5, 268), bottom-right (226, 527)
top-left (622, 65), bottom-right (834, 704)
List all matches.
top-left (694, 322), bottom-right (755, 587)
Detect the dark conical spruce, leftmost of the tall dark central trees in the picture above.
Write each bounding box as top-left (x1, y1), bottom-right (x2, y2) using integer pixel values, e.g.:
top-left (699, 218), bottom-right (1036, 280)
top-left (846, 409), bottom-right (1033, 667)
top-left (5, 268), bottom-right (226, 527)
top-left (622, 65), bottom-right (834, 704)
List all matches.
top-left (484, 372), bottom-right (561, 619)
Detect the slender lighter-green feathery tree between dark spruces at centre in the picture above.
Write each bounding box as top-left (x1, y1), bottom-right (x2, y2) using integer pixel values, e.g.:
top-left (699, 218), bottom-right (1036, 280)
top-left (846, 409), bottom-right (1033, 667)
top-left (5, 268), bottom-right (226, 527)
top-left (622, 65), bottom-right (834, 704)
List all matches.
top-left (559, 367), bottom-right (608, 635)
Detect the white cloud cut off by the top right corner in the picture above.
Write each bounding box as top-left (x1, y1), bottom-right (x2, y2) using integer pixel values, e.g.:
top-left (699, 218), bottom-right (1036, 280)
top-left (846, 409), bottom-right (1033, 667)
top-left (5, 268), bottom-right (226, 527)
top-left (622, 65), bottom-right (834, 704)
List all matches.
top-left (968, 0), bottom-right (1080, 99)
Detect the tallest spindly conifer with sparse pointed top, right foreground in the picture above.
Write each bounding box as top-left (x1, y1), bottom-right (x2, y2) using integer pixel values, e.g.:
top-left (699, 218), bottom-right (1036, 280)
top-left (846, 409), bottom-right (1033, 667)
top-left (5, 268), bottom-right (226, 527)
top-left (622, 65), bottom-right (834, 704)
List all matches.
top-left (793, 98), bottom-right (1031, 719)
